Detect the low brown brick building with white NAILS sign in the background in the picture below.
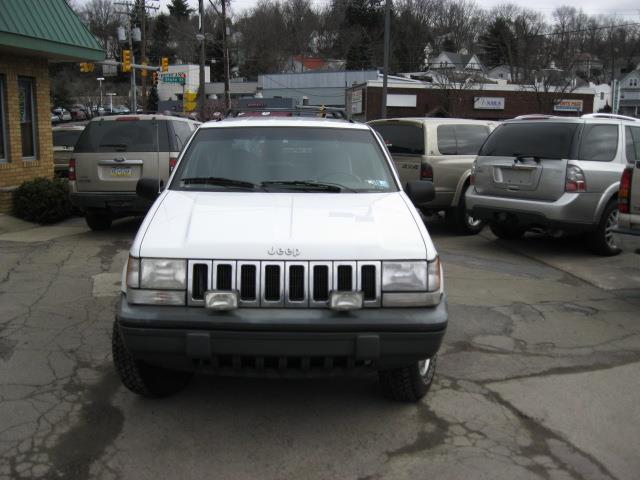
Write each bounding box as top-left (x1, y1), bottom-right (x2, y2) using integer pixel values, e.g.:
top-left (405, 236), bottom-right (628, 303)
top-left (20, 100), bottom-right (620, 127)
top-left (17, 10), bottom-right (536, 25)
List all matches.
top-left (347, 80), bottom-right (596, 121)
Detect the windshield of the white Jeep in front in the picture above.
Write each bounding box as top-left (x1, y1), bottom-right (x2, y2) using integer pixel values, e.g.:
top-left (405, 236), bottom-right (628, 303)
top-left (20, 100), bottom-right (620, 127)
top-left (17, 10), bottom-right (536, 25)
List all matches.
top-left (171, 127), bottom-right (397, 193)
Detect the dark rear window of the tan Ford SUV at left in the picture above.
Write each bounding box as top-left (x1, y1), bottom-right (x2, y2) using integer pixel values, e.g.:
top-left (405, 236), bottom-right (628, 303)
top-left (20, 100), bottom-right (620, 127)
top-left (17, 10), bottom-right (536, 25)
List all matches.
top-left (75, 120), bottom-right (169, 153)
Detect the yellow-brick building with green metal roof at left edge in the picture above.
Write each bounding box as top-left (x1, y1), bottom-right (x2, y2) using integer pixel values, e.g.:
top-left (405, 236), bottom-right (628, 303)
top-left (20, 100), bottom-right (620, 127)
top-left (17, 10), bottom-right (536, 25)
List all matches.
top-left (0, 0), bottom-right (104, 213)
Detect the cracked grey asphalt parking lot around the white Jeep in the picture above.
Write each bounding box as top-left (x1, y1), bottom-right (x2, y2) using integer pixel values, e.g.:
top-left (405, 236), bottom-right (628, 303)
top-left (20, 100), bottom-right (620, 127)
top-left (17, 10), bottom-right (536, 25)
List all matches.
top-left (0, 219), bottom-right (640, 480)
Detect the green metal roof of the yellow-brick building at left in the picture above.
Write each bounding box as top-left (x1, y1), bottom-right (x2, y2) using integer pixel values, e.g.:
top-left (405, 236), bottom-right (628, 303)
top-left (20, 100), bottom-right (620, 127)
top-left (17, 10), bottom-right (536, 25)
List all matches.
top-left (0, 0), bottom-right (105, 62)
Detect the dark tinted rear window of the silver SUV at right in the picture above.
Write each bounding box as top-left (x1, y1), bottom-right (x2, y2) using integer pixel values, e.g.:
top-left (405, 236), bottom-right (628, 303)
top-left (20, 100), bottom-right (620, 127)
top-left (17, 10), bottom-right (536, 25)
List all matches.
top-left (479, 121), bottom-right (579, 160)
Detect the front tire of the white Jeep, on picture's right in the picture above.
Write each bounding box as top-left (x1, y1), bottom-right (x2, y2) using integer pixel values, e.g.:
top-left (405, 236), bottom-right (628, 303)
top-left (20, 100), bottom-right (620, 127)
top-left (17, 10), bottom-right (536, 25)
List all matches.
top-left (378, 355), bottom-right (437, 402)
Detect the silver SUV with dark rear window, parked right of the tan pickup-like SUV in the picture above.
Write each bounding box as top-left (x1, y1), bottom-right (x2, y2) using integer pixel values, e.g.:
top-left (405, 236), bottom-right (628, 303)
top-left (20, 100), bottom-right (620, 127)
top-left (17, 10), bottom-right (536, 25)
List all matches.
top-left (466, 114), bottom-right (640, 255)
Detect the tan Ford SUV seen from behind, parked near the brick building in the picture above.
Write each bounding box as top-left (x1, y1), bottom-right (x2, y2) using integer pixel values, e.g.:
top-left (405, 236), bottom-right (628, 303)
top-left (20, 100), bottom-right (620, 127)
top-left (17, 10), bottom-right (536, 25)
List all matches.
top-left (69, 115), bottom-right (197, 230)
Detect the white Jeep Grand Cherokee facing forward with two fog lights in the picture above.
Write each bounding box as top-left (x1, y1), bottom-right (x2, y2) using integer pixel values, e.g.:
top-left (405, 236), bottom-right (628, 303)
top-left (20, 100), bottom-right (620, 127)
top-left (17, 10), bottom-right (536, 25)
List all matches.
top-left (113, 112), bottom-right (447, 401)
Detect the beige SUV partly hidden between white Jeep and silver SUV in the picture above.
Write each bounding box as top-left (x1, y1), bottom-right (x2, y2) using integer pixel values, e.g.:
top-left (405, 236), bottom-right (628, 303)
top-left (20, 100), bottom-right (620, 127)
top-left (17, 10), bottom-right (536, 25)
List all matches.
top-left (369, 118), bottom-right (496, 235)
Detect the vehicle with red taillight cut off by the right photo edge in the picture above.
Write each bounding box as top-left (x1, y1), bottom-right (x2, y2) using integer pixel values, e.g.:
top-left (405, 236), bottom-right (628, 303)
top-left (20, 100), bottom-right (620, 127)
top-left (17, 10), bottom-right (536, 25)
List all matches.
top-left (617, 133), bottom-right (640, 235)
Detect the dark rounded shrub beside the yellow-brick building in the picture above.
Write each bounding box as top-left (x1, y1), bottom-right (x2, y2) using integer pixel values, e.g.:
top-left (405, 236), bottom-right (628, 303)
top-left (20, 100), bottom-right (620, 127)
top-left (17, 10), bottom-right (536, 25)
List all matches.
top-left (13, 178), bottom-right (71, 224)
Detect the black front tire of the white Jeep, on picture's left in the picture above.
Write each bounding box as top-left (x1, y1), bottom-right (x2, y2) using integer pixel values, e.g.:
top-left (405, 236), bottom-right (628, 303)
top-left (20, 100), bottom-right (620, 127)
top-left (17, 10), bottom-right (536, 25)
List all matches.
top-left (111, 322), bottom-right (193, 398)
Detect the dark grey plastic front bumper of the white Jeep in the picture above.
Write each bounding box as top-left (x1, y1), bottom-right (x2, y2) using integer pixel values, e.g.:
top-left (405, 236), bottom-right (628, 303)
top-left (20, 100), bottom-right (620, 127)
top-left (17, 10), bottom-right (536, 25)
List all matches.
top-left (116, 295), bottom-right (447, 368)
